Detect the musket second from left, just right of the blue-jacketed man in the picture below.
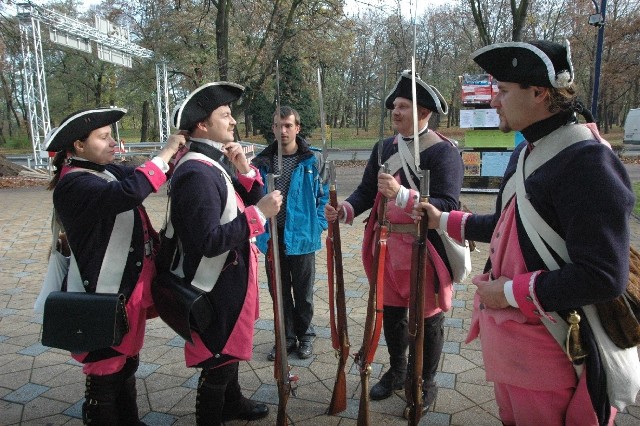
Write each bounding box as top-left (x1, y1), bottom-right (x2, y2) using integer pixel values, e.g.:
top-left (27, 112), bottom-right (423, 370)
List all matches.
top-left (318, 68), bottom-right (350, 415)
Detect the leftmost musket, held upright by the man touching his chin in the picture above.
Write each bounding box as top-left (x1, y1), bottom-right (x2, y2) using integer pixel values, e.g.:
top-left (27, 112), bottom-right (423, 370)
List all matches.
top-left (267, 61), bottom-right (298, 426)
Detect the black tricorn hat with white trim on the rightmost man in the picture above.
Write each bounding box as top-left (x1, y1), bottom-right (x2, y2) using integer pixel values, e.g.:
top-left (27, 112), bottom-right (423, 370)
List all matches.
top-left (471, 40), bottom-right (574, 88)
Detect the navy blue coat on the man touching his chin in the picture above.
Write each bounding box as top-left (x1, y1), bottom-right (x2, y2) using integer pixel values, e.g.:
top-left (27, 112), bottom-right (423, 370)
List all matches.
top-left (171, 155), bottom-right (263, 366)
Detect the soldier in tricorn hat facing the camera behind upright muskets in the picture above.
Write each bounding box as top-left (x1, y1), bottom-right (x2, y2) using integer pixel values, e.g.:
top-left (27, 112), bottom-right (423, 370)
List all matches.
top-left (325, 71), bottom-right (464, 411)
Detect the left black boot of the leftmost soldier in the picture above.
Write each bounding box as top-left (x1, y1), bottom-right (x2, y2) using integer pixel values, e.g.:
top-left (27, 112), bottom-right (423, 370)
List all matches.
top-left (82, 372), bottom-right (123, 426)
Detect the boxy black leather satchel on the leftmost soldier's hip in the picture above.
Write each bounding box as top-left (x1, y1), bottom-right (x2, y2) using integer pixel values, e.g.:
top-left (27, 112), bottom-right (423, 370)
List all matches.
top-left (42, 291), bottom-right (129, 352)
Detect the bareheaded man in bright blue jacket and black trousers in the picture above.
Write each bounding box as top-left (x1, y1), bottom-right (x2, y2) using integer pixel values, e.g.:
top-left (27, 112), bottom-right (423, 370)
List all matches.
top-left (253, 106), bottom-right (328, 361)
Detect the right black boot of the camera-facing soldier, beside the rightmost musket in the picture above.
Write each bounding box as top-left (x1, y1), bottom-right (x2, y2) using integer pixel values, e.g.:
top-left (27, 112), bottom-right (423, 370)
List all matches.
top-left (422, 312), bottom-right (444, 412)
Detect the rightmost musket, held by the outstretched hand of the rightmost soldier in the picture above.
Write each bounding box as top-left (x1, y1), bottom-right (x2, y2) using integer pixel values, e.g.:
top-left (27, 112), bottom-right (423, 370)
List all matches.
top-left (404, 170), bottom-right (429, 425)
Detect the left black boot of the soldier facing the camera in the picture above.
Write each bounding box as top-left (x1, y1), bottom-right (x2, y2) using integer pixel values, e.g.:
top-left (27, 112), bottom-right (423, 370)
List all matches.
top-left (369, 306), bottom-right (409, 401)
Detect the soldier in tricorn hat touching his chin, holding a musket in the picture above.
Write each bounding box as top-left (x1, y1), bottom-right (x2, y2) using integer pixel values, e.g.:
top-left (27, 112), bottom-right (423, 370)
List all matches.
top-left (171, 82), bottom-right (282, 425)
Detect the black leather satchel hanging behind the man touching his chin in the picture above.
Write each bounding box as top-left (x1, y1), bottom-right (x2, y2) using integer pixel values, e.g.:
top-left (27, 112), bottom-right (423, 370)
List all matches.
top-left (151, 271), bottom-right (214, 343)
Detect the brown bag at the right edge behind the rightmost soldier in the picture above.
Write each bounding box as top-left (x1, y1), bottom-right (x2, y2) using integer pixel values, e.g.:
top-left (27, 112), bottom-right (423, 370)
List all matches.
top-left (596, 247), bottom-right (640, 349)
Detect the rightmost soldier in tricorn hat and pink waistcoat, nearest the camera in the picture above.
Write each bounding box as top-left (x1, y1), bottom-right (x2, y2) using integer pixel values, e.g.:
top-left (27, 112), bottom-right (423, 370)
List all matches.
top-left (421, 41), bottom-right (640, 425)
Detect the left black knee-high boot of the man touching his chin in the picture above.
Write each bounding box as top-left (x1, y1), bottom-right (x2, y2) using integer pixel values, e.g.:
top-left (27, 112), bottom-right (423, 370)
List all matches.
top-left (196, 362), bottom-right (238, 426)
